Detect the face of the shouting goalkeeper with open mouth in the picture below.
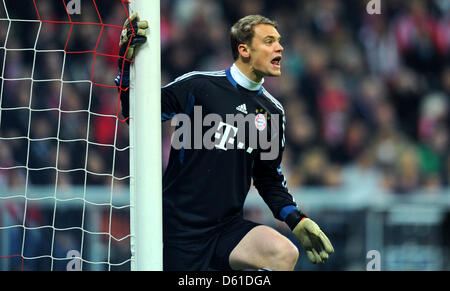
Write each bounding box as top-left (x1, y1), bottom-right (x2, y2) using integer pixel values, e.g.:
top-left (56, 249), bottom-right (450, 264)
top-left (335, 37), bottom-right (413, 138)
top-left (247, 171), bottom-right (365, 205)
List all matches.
top-left (249, 24), bottom-right (283, 77)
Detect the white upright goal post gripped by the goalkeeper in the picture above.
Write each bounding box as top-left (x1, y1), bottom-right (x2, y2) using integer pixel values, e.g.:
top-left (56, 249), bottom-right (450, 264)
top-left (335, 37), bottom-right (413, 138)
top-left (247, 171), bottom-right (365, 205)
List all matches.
top-left (130, 0), bottom-right (162, 271)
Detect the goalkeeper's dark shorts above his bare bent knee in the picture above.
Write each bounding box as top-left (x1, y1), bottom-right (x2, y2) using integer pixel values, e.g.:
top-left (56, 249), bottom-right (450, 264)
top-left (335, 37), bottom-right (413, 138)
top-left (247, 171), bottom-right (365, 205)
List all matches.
top-left (163, 217), bottom-right (260, 271)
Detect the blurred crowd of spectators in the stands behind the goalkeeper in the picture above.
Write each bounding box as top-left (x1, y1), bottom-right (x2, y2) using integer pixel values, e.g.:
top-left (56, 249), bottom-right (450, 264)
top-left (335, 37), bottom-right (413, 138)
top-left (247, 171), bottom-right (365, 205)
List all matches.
top-left (0, 0), bottom-right (450, 194)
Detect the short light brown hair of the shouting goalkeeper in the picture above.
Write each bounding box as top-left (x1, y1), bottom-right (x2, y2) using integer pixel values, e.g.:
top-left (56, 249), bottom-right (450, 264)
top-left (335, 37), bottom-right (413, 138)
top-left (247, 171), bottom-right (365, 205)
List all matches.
top-left (230, 15), bottom-right (278, 60)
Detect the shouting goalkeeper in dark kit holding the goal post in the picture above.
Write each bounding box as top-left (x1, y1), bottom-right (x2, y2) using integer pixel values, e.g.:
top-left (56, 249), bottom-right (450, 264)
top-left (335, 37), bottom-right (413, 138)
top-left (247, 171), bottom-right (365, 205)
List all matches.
top-left (115, 14), bottom-right (334, 271)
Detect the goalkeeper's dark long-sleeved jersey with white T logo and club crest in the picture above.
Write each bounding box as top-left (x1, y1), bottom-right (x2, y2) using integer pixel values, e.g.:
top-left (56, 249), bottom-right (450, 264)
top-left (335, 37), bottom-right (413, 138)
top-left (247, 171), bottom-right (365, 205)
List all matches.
top-left (156, 65), bottom-right (296, 240)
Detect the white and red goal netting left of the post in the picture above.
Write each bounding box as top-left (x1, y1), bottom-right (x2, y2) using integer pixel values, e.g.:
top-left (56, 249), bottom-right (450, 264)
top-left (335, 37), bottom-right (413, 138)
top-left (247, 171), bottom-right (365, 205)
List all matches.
top-left (0, 0), bottom-right (161, 270)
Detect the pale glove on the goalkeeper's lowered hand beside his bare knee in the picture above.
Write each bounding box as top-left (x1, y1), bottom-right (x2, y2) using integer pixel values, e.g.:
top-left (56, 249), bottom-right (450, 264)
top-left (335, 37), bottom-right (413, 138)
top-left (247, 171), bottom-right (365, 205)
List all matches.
top-left (292, 217), bottom-right (334, 264)
